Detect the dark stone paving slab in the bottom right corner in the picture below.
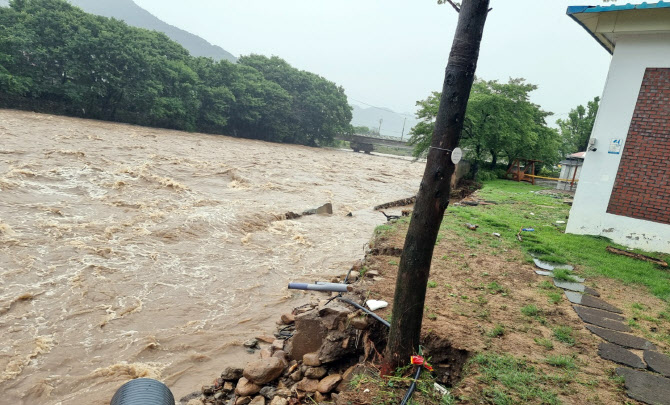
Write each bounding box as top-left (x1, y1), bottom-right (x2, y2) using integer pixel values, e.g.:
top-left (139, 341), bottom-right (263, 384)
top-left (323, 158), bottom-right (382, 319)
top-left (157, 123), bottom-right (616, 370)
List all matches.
top-left (616, 368), bottom-right (670, 405)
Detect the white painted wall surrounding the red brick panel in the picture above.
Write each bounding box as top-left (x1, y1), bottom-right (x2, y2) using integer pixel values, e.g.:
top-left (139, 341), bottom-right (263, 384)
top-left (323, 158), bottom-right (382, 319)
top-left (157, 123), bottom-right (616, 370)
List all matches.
top-left (567, 34), bottom-right (670, 253)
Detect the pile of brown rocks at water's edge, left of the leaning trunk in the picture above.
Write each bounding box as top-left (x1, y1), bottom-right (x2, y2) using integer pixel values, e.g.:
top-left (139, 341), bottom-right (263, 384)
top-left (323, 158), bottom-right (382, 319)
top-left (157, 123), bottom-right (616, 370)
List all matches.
top-left (197, 288), bottom-right (374, 405)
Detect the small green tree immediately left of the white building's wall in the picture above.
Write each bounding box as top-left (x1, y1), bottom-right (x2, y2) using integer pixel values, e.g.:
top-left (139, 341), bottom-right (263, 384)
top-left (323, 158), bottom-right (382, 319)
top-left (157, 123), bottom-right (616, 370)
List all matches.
top-left (556, 97), bottom-right (600, 156)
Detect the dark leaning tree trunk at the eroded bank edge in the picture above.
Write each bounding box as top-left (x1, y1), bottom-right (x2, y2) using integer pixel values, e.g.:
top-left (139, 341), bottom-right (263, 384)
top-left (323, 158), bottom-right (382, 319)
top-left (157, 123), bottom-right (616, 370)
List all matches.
top-left (381, 0), bottom-right (489, 375)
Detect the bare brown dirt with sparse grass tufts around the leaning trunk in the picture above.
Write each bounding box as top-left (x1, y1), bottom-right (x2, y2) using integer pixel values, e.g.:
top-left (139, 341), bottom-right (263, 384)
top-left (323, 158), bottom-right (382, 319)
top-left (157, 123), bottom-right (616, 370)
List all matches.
top-left (348, 207), bottom-right (670, 404)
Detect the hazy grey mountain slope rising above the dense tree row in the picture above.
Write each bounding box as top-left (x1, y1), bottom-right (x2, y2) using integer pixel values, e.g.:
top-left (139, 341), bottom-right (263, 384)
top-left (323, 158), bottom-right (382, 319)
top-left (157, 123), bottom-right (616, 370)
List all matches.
top-left (0, 0), bottom-right (237, 62)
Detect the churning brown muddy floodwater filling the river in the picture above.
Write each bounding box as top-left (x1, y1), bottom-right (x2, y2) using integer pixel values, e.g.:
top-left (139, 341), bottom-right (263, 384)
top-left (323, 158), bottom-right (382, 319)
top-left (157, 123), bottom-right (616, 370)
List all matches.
top-left (0, 110), bottom-right (424, 405)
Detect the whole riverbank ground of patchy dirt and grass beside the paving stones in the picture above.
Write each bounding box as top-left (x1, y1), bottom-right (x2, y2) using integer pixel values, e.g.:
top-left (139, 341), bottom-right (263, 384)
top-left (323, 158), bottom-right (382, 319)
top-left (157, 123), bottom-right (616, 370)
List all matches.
top-left (357, 181), bottom-right (670, 404)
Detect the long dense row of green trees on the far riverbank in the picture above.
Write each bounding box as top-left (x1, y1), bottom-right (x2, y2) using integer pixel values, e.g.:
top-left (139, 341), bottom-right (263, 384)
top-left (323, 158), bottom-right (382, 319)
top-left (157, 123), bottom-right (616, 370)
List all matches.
top-left (0, 0), bottom-right (351, 145)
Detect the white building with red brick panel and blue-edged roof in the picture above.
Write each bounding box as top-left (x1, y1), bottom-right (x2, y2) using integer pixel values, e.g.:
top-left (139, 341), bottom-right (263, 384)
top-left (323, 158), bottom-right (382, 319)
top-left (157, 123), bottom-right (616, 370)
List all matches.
top-left (567, 2), bottom-right (670, 253)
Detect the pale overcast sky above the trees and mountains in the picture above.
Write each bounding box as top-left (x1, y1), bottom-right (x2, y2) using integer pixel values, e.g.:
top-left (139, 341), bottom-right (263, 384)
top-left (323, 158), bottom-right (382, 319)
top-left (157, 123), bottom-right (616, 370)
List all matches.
top-left (135, 0), bottom-right (611, 121)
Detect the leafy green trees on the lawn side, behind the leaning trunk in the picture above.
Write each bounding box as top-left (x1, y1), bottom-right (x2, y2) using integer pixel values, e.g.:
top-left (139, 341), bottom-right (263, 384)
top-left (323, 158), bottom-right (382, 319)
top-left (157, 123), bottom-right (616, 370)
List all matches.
top-left (409, 79), bottom-right (599, 174)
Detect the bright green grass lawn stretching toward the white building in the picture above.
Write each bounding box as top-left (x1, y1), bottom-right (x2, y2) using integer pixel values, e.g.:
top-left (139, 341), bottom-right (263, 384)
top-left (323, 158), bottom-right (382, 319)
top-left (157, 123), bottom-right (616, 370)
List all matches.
top-left (442, 180), bottom-right (670, 302)
